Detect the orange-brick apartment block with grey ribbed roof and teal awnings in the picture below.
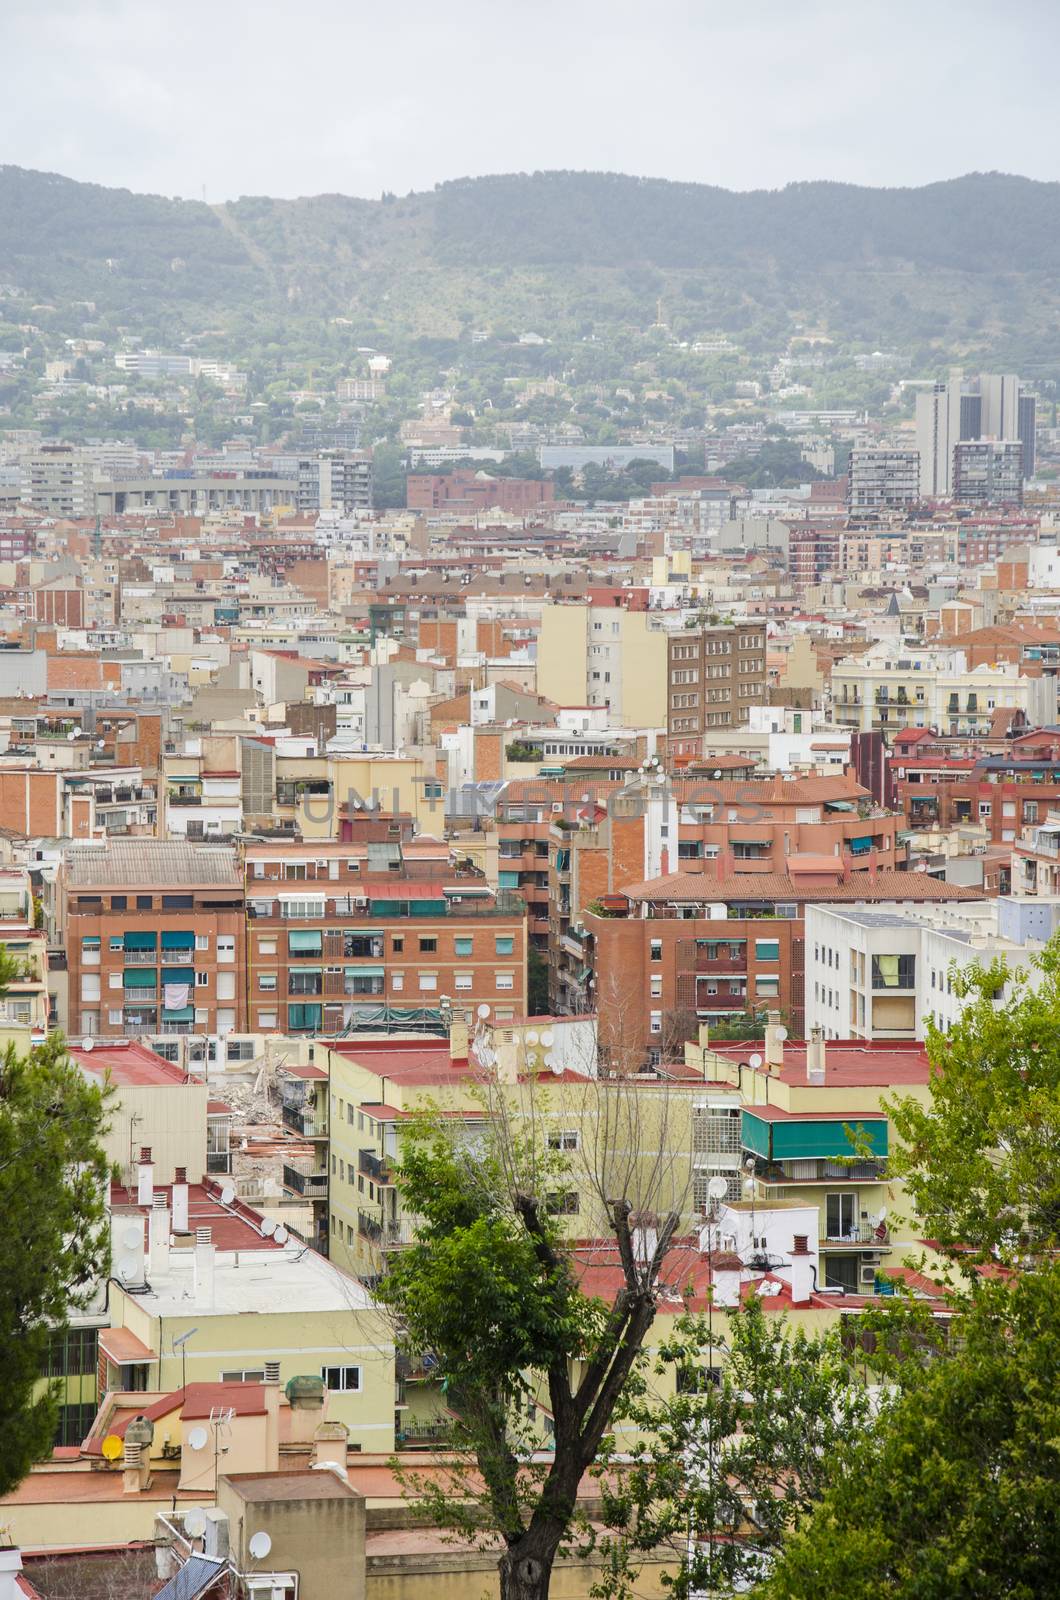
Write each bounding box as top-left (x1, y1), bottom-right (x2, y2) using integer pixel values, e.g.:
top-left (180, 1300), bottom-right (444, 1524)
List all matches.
top-left (58, 838), bottom-right (247, 1037)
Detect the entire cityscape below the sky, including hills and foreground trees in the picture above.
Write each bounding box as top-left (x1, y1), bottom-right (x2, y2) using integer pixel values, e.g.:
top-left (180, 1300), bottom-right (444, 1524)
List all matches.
top-left (0, 6), bottom-right (1060, 1600)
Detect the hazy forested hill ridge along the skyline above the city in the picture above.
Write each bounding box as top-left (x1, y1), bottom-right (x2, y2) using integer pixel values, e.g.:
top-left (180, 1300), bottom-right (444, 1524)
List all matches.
top-left (0, 166), bottom-right (1060, 358)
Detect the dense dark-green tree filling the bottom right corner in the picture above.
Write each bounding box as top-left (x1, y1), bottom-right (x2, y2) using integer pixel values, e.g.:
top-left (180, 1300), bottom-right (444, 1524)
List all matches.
top-left (756, 1262), bottom-right (1060, 1600)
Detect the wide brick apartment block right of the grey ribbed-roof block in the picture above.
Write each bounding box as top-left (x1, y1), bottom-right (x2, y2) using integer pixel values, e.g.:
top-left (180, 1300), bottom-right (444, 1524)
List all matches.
top-left (245, 838), bottom-right (527, 1035)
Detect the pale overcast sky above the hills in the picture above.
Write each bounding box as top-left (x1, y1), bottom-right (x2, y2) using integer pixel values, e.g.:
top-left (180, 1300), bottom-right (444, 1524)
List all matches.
top-left (0, 0), bottom-right (1060, 200)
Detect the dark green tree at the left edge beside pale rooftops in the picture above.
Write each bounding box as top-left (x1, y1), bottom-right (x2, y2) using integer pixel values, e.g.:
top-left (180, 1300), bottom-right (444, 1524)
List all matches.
top-left (0, 1004), bottom-right (109, 1494)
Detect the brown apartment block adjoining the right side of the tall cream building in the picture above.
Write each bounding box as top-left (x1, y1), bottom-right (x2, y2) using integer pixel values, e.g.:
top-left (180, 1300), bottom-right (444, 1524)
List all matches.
top-left (666, 622), bottom-right (769, 755)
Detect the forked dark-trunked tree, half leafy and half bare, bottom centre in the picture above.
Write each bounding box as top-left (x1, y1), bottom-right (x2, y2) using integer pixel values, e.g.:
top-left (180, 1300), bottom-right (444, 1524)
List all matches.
top-left (379, 1082), bottom-right (687, 1600)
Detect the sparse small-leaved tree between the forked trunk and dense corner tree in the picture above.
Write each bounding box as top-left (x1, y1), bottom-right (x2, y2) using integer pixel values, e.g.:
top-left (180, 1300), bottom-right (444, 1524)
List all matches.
top-left (594, 1296), bottom-right (871, 1600)
